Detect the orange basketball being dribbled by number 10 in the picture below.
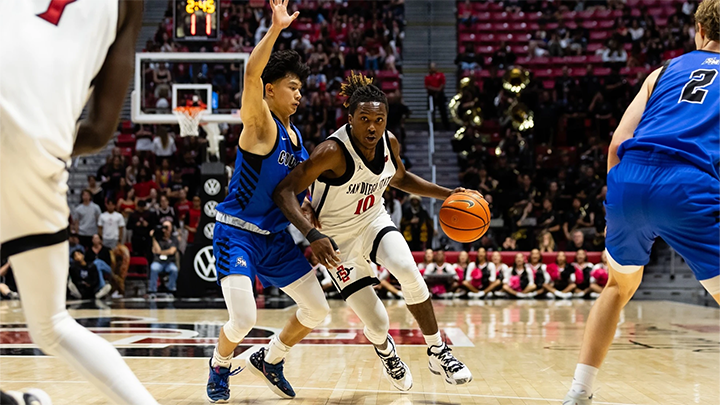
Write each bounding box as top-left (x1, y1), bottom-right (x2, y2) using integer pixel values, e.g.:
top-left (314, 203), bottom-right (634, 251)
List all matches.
top-left (440, 193), bottom-right (490, 243)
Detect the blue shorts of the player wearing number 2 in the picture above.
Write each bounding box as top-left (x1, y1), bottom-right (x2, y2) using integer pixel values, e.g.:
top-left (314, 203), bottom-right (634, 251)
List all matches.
top-left (605, 151), bottom-right (720, 281)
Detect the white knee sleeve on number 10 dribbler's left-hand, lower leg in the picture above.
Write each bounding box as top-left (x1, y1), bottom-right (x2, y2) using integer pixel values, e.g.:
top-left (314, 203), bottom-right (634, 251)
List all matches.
top-left (347, 286), bottom-right (390, 346)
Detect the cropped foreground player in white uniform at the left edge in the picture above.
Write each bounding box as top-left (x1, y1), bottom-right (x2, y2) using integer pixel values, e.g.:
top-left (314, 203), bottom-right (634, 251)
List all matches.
top-left (0, 0), bottom-right (157, 405)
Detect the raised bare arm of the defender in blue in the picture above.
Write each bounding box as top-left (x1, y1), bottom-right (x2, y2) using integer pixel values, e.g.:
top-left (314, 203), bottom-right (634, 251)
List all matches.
top-left (240, 0), bottom-right (300, 142)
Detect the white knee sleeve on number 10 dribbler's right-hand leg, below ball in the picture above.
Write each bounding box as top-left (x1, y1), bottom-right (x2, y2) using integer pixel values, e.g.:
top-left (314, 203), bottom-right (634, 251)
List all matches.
top-left (376, 232), bottom-right (430, 305)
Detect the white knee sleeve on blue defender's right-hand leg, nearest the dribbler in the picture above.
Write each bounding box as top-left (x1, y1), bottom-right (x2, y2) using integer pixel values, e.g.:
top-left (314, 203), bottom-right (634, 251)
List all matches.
top-left (282, 272), bottom-right (330, 329)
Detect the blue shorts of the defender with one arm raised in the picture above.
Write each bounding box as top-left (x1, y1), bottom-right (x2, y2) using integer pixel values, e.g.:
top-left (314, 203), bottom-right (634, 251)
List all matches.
top-left (213, 222), bottom-right (312, 288)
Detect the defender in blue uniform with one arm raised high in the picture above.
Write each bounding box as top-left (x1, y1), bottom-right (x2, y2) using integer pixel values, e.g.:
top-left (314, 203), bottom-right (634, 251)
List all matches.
top-left (207, 0), bottom-right (330, 403)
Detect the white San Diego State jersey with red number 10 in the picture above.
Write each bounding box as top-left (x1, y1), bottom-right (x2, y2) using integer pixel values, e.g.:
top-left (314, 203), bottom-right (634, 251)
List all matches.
top-left (311, 125), bottom-right (397, 238)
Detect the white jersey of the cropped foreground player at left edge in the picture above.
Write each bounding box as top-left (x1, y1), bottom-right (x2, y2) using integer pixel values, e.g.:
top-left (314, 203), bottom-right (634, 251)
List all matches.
top-left (0, 0), bottom-right (118, 161)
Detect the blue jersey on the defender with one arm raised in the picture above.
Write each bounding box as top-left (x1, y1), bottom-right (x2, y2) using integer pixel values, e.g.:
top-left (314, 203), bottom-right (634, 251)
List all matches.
top-left (217, 115), bottom-right (308, 233)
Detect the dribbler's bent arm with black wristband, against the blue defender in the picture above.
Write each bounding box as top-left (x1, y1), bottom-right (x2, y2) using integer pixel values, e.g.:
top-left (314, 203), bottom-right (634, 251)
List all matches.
top-left (273, 141), bottom-right (345, 268)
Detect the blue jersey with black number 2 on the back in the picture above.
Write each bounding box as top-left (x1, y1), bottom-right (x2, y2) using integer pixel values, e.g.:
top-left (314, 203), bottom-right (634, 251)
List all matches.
top-left (618, 51), bottom-right (720, 179)
